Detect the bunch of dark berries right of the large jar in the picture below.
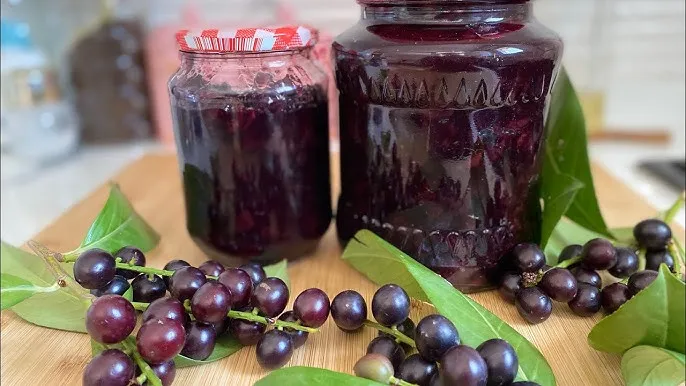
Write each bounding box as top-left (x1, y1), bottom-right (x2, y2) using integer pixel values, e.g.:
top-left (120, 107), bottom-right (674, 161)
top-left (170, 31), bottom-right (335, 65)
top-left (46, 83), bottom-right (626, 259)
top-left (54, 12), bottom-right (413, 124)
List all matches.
top-left (499, 219), bottom-right (675, 324)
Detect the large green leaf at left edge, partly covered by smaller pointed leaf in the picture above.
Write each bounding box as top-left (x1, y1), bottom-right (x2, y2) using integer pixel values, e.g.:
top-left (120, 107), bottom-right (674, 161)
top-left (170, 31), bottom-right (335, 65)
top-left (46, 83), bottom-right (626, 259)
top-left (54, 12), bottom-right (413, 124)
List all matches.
top-left (0, 242), bottom-right (89, 332)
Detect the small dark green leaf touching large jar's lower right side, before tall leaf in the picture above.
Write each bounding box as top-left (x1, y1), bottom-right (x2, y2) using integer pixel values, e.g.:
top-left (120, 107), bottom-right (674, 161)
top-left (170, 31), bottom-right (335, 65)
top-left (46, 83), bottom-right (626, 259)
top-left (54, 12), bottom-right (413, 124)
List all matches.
top-left (541, 163), bottom-right (584, 248)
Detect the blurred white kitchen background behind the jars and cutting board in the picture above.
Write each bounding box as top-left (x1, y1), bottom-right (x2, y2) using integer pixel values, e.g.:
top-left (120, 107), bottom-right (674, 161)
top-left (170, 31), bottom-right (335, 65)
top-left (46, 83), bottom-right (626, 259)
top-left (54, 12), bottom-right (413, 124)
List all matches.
top-left (0, 0), bottom-right (686, 244)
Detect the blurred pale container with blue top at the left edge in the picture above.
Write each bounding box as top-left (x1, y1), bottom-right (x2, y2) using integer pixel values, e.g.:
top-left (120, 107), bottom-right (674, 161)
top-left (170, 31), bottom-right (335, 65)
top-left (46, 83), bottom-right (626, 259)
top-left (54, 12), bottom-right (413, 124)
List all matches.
top-left (0, 20), bottom-right (79, 170)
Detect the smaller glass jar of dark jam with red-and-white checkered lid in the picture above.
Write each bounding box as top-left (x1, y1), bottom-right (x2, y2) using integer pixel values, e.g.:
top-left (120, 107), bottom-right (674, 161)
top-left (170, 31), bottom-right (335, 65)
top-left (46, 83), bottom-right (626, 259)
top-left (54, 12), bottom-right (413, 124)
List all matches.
top-left (169, 27), bottom-right (332, 265)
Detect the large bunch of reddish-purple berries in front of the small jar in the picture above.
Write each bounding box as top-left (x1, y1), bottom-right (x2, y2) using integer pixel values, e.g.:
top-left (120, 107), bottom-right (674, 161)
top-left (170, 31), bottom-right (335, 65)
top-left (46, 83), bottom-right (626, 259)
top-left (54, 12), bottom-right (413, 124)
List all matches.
top-left (74, 247), bottom-right (330, 386)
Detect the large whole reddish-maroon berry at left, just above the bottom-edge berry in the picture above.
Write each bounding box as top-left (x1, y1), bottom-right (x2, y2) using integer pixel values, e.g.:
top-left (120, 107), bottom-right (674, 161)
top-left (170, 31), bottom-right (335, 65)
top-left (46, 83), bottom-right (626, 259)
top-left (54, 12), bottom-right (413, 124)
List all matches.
top-left (86, 295), bottom-right (136, 344)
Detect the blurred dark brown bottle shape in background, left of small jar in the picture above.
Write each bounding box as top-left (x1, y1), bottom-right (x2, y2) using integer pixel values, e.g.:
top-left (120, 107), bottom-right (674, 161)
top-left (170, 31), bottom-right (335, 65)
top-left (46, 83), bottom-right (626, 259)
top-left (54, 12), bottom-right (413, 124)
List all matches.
top-left (68, 1), bottom-right (153, 143)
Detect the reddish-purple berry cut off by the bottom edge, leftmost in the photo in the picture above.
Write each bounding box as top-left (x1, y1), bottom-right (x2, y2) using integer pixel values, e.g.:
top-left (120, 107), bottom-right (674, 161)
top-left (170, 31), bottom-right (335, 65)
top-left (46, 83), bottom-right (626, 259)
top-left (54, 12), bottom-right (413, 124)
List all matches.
top-left (82, 349), bottom-right (136, 386)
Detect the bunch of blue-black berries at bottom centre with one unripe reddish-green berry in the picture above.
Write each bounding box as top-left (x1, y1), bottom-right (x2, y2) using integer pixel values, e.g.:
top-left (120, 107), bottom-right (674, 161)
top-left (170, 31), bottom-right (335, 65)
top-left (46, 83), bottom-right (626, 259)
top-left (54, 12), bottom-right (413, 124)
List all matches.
top-left (331, 284), bottom-right (536, 386)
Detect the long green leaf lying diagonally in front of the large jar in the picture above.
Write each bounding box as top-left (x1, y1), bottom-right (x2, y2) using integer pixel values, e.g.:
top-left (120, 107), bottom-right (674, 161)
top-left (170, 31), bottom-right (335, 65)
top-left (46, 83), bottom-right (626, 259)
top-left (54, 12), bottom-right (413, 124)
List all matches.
top-left (343, 230), bottom-right (555, 386)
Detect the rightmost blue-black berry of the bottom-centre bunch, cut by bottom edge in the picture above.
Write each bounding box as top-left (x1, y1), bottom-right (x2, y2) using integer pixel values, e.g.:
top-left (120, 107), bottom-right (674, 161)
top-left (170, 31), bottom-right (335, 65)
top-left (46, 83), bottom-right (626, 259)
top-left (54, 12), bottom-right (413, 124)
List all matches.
top-left (476, 339), bottom-right (519, 386)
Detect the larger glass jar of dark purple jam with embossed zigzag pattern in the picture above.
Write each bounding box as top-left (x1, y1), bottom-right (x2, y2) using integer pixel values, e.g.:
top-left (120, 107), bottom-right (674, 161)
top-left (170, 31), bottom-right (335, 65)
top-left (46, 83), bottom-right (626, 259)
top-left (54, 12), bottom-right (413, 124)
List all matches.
top-left (334, 0), bottom-right (562, 291)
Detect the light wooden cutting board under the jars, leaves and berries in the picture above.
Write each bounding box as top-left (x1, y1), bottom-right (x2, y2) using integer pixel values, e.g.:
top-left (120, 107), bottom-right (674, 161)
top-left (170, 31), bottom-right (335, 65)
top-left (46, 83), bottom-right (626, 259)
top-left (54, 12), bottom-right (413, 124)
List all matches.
top-left (0, 155), bottom-right (684, 386)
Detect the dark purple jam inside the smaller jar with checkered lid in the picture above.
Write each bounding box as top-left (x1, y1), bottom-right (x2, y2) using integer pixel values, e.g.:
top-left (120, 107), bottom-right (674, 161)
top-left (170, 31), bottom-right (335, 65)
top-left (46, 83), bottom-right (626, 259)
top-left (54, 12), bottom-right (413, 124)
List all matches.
top-left (171, 82), bottom-right (331, 263)
